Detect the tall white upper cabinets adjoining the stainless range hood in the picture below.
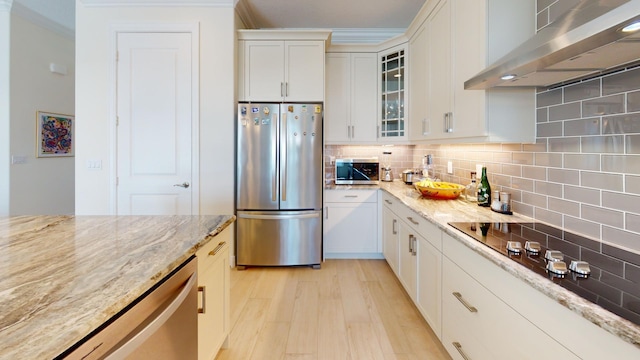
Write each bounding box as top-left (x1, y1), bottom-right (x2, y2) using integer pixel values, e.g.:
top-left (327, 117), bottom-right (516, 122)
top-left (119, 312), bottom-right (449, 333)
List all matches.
top-left (409, 0), bottom-right (535, 143)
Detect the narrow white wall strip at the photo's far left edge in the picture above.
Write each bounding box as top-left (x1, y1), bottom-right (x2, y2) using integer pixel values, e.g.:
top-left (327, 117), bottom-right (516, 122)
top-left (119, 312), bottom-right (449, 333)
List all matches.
top-left (0, 0), bottom-right (11, 216)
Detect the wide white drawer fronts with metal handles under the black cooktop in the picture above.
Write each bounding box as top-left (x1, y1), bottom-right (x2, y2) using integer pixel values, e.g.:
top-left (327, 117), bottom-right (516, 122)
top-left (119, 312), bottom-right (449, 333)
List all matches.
top-left (442, 257), bottom-right (578, 359)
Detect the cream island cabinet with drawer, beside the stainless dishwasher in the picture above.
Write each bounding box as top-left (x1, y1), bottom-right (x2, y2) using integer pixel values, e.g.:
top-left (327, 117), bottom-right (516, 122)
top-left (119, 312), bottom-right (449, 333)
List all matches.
top-left (196, 227), bottom-right (233, 360)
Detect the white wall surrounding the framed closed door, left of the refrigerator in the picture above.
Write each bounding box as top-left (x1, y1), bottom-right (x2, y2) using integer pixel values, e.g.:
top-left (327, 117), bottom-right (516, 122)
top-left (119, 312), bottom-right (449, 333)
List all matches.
top-left (76, 0), bottom-right (235, 215)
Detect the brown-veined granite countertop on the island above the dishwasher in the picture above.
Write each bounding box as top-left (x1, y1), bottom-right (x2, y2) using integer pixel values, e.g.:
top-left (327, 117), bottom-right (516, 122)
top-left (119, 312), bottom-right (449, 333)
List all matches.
top-left (0, 215), bottom-right (235, 359)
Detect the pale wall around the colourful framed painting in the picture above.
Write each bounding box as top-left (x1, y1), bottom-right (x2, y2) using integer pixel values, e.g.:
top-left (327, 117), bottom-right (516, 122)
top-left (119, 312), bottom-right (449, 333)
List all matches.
top-left (10, 12), bottom-right (75, 215)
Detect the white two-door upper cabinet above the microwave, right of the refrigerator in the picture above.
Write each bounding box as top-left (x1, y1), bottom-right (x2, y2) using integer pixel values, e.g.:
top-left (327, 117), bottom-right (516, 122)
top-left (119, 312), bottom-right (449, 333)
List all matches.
top-left (324, 52), bottom-right (378, 144)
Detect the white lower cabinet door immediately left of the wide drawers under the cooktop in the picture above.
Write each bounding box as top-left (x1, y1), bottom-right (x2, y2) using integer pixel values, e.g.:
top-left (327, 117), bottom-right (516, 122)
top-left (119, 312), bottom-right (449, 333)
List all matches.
top-left (417, 235), bottom-right (442, 339)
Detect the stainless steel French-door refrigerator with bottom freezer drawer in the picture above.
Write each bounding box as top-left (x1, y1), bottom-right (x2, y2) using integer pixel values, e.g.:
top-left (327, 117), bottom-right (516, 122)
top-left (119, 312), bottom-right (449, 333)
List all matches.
top-left (236, 103), bottom-right (323, 269)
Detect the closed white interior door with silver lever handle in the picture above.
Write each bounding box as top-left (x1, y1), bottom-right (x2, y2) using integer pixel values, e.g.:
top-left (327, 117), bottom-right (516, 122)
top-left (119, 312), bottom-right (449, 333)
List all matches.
top-left (117, 33), bottom-right (193, 215)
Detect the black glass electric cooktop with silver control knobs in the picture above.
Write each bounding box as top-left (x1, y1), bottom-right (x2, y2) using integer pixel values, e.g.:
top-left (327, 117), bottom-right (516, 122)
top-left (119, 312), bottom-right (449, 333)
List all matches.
top-left (449, 222), bottom-right (640, 325)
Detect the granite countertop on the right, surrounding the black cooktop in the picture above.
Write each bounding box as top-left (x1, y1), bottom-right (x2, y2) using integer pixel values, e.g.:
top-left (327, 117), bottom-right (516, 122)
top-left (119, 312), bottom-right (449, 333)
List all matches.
top-left (379, 181), bottom-right (640, 347)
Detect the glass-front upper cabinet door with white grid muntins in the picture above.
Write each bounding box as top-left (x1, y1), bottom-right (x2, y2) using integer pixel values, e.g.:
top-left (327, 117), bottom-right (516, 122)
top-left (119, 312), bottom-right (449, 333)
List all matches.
top-left (379, 44), bottom-right (407, 142)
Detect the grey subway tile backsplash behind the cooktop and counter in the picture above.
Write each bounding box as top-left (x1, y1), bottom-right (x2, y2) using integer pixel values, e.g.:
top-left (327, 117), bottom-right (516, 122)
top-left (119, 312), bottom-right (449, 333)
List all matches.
top-left (325, 67), bottom-right (640, 253)
